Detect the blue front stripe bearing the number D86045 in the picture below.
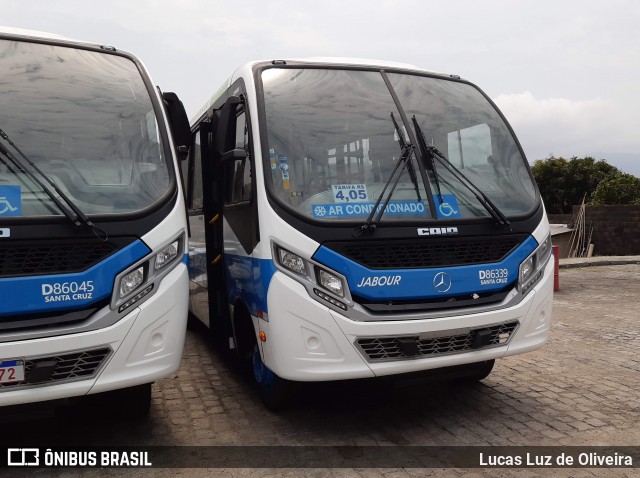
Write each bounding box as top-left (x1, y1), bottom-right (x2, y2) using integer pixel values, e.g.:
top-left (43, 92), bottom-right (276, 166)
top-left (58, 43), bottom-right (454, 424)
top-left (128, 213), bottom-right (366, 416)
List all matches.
top-left (0, 240), bottom-right (151, 320)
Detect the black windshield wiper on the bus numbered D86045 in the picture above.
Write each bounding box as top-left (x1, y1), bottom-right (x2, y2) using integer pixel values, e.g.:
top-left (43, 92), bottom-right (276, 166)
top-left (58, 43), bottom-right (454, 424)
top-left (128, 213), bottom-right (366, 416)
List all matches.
top-left (0, 128), bottom-right (107, 240)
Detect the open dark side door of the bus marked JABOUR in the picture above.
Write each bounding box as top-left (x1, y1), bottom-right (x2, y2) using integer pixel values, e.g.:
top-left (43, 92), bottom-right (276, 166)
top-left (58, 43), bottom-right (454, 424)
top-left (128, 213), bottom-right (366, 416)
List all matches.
top-left (200, 96), bottom-right (257, 352)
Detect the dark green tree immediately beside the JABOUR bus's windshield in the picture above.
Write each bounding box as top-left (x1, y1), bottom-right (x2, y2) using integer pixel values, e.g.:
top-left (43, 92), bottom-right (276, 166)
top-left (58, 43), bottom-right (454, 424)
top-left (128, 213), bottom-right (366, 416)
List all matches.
top-left (531, 156), bottom-right (620, 214)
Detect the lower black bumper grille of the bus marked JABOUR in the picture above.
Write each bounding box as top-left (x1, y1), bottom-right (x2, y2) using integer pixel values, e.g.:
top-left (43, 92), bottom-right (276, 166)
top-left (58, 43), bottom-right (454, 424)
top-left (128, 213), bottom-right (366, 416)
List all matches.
top-left (356, 321), bottom-right (519, 362)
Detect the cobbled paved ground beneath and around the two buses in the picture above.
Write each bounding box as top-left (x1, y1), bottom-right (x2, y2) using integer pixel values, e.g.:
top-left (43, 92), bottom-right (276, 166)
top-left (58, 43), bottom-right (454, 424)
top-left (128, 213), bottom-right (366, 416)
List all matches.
top-left (0, 264), bottom-right (640, 478)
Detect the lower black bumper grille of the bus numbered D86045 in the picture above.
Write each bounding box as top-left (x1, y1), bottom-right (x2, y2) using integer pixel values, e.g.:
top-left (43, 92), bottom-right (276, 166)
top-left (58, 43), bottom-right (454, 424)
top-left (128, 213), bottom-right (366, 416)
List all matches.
top-left (0, 347), bottom-right (111, 393)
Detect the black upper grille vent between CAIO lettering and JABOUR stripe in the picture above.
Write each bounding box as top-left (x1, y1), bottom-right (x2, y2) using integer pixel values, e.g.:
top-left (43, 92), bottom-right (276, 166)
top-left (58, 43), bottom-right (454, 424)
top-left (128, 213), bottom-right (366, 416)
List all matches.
top-left (325, 236), bottom-right (526, 269)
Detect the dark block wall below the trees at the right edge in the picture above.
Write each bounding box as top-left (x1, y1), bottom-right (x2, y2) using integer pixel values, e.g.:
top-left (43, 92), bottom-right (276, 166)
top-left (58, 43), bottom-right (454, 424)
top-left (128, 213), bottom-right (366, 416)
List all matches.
top-left (573, 205), bottom-right (640, 256)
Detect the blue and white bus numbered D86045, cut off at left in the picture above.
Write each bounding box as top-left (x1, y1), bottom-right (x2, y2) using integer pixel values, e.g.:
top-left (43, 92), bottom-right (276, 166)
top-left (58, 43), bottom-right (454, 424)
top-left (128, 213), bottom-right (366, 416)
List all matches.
top-left (0, 28), bottom-right (191, 416)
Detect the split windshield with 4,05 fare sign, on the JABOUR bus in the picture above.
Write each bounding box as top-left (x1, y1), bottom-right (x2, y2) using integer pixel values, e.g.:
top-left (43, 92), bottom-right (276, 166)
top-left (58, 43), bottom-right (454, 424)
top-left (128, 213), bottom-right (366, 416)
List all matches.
top-left (262, 68), bottom-right (536, 223)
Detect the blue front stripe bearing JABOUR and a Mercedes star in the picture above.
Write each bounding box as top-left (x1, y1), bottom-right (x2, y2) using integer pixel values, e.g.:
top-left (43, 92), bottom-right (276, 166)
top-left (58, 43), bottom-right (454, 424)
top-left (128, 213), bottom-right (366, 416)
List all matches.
top-left (313, 237), bottom-right (538, 300)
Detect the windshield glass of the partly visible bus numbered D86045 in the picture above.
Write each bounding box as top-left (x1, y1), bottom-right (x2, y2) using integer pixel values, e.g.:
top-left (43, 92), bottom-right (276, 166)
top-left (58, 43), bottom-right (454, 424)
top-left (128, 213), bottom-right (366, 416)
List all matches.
top-left (0, 39), bottom-right (171, 217)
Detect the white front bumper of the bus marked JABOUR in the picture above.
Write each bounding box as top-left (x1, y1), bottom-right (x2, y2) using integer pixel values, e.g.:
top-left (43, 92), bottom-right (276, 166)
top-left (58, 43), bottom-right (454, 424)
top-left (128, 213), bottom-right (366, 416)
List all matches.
top-left (258, 261), bottom-right (553, 381)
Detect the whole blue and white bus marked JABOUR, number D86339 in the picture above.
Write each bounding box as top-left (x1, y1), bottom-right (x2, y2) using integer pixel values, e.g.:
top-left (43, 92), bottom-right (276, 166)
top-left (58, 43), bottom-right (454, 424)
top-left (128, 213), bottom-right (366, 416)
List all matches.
top-left (183, 59), bottom-right (553, 407)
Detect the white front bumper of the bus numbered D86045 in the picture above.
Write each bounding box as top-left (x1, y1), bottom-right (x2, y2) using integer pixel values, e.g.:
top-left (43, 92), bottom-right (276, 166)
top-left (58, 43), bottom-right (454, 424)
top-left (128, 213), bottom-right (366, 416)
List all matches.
top-left (0, 264), bottom-right (188, 406)
